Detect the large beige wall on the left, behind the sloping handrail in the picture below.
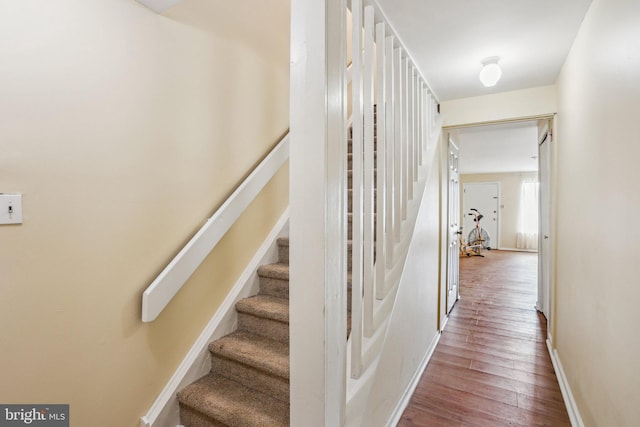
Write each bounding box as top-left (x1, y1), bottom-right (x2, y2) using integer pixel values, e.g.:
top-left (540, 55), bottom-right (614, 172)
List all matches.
top-left (0, 0), bottom-right (289, 427)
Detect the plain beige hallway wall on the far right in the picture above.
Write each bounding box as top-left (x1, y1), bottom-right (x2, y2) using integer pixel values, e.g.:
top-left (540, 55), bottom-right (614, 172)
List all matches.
top-left (555, 0), bottom-right (640, 427)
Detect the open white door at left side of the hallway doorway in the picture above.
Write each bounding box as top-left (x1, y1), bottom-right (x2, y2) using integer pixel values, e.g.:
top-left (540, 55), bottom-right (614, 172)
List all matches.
top-left (447, 136), bottom-right (460, 314)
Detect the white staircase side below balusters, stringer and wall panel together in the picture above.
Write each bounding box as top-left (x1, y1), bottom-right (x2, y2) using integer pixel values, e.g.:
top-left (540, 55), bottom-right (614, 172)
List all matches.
top-left (345, 127), bottom-right (440, 427)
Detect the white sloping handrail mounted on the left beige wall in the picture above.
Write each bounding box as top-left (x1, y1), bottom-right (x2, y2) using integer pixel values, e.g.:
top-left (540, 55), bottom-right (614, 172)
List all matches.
top-left (142, 133), bottom-right (289, 322)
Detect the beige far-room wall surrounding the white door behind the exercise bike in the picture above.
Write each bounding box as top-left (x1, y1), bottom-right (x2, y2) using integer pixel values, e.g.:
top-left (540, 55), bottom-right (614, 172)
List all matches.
top-left (460, 172), bottom-right (538, 249)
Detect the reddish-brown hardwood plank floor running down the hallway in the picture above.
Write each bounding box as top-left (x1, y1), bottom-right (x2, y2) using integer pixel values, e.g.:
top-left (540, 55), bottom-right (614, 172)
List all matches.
top-left (398, 251), bottom-right (571, 427)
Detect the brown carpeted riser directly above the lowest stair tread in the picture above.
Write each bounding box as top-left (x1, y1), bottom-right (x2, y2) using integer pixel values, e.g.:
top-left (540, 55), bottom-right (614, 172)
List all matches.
top-left (211, 354), bottom-right (289, 402)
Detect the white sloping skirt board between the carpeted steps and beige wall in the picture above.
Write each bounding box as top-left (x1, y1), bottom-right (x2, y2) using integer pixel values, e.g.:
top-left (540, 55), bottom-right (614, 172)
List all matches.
top-left (140, 209), bottom-right (289, 427)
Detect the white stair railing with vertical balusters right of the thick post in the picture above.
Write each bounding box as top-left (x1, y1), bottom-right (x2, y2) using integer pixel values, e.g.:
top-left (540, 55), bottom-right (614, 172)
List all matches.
top-left (349, 0), bottom-right (437, 379)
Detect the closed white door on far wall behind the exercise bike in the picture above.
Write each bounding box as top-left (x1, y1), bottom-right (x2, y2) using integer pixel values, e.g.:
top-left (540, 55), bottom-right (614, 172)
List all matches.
top-left (462, 182), bottom-right (500, 249)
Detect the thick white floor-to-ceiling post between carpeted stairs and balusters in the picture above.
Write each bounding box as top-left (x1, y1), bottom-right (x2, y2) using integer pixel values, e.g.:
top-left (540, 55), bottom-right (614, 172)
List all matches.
top-left (289, 0), bottom-right (347, 427)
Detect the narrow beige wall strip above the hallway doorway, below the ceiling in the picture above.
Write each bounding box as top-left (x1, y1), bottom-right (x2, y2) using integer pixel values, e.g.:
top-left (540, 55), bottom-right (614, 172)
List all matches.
top-left (440, 86), bottom-right (557, 126)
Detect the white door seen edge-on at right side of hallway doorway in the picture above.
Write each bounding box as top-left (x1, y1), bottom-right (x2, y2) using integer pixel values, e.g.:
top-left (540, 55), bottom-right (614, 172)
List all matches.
top-left (536, 133), bottom-right (551, 319)
